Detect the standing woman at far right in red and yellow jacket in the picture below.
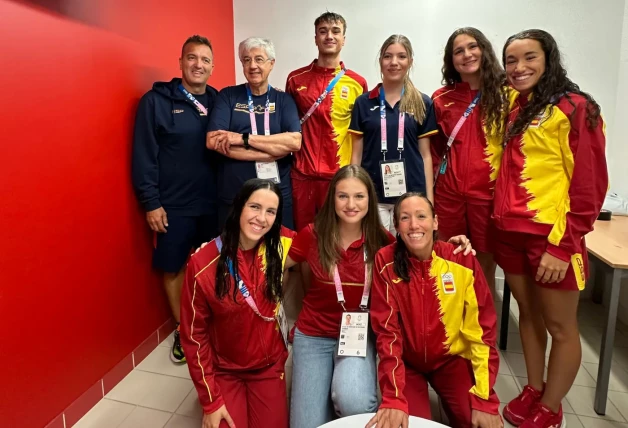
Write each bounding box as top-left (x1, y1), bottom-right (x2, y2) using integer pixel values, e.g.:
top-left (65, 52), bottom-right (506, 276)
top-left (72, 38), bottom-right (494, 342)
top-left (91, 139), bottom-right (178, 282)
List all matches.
top-left (494, 30), bottom-right (608, 428)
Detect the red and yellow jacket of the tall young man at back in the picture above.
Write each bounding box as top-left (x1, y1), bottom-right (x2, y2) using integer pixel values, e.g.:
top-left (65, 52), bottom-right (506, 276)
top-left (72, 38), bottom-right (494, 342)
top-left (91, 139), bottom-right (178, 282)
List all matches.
top-left (286, 60), bottom-right (367, 180)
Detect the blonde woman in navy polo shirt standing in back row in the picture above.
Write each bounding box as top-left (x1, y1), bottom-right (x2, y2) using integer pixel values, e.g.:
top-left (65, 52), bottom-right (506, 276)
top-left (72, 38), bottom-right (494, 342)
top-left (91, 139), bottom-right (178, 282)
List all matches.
top-left (349, 34), bottom-right (438, 233)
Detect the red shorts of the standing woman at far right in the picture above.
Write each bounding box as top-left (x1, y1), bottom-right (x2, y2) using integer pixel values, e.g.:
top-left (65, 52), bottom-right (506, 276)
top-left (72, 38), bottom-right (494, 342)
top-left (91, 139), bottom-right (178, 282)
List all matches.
top-left (495, 230), bottom-right (589, 290)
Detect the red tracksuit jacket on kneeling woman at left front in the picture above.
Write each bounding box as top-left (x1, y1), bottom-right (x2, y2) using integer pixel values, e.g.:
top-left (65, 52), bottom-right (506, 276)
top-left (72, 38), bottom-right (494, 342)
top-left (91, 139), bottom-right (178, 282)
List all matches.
top-left (180, 228), bottom-right (294, 413)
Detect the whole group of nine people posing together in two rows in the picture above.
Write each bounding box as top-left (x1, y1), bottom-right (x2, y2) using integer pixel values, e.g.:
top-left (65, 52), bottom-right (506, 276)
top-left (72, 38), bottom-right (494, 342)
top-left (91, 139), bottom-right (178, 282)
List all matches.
top-left (133, 12), bottom-right (608, 428)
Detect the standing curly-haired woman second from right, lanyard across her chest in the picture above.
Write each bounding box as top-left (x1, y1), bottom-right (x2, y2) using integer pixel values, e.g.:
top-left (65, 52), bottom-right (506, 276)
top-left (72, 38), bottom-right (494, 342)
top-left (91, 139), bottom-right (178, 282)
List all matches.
top-left (432, 27), bottom-right (508, 294)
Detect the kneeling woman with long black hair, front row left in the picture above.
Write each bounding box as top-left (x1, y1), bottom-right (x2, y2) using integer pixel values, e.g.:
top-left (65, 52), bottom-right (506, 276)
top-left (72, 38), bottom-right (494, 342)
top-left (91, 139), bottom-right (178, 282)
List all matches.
top-left (181, 179), bottom-right (294, 428)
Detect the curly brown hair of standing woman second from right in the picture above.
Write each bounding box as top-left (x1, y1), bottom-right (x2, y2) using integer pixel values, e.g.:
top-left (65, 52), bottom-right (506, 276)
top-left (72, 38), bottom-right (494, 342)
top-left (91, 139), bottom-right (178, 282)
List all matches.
top-left (441, 27), bottom-right (508, 135)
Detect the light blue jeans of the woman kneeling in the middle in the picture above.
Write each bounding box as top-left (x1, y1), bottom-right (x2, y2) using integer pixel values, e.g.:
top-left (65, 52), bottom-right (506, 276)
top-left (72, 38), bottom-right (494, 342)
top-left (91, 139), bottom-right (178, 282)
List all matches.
top-left (290, 329), bottom-right (378, 428)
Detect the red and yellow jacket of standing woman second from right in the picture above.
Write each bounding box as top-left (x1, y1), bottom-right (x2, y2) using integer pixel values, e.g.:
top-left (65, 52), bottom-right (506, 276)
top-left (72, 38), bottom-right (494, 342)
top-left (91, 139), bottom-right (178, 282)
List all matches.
top-left (430, 82), bottom-right (510, 201)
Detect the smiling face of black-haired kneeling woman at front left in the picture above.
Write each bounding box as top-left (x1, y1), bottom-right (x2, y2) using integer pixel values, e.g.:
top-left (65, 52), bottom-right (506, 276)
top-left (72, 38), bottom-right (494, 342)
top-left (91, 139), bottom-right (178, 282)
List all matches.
top-left (240, 189), bottom-right (279, 249)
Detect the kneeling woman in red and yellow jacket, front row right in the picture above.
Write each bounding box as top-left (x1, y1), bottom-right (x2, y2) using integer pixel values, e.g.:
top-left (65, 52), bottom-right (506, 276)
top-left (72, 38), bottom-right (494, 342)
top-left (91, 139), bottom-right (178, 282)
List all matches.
top-left (367, 193), bottom-right (503, 428)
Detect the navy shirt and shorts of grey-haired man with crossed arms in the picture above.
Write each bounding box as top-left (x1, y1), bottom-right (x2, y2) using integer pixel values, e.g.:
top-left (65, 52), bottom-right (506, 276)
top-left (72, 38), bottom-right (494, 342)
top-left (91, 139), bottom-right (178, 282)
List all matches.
top-left (207, 84), bottom-right (301, 229)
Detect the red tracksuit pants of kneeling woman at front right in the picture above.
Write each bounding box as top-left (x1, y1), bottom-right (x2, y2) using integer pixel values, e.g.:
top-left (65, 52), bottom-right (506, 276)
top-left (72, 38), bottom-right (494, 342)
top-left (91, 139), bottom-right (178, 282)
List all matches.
top-left (404, 357), bottom-right (475, 428)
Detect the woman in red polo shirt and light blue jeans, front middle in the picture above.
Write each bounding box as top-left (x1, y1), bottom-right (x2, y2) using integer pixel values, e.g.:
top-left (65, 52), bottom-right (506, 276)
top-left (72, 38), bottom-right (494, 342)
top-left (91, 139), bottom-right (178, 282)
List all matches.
top-left (286, 165), bottom-right (470, 428)
